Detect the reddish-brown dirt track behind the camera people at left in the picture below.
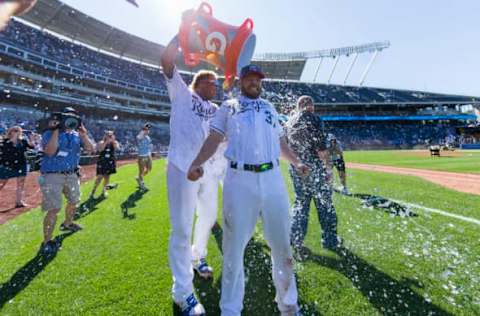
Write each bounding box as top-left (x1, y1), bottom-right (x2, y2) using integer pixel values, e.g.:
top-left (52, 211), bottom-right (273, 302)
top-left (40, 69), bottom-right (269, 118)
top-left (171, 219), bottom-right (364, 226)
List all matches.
top-left (0, 160), bottom-right (136, 225)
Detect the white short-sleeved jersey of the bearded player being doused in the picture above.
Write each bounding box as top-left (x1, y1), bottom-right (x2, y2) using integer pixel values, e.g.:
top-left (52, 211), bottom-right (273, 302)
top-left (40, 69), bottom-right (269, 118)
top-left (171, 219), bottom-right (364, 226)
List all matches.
top-left (210, 96), bottom-right (283, 164)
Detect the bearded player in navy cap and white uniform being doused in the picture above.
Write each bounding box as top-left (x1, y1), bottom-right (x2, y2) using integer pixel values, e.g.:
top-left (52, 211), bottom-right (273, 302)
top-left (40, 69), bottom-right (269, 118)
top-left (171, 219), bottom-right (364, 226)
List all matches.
top-left (188, 65), bottom-right (309, 316)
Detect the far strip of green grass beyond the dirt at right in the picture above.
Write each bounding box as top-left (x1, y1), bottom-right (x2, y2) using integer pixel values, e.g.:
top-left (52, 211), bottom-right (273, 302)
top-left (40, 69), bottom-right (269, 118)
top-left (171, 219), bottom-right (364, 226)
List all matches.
top-left (345, 150), bottom-right (480, 173)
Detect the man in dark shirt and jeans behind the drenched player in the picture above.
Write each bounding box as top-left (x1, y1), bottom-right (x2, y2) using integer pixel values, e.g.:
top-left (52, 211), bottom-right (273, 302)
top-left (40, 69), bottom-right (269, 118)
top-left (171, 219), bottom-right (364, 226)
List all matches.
top-left (286, 96), bottom-right (339, 259)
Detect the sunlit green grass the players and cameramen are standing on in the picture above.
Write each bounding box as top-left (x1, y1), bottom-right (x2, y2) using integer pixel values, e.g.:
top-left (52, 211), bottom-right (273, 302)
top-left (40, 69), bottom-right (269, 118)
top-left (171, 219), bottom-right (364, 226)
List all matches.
top-left (0, 157), bottom-right (480, 316)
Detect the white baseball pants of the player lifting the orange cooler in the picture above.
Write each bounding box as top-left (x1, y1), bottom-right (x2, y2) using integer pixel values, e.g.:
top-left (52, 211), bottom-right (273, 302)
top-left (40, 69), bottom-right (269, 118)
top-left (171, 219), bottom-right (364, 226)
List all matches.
top-left (167, 163), bottom-right (218, 302)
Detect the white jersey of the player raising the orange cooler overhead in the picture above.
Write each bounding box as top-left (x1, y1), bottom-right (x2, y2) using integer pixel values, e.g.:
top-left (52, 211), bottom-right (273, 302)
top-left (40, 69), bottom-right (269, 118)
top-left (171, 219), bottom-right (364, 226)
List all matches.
top-left (166, 68), bottom-right (217, 172)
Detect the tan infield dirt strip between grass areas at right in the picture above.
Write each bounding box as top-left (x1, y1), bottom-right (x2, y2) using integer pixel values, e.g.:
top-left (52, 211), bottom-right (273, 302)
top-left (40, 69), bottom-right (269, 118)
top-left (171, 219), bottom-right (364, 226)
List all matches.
top-left (347, 163), bottom-right (480, 195)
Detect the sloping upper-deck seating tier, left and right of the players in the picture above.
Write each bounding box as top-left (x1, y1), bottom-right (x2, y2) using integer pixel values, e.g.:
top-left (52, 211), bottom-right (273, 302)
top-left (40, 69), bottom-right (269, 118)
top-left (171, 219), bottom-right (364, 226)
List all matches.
top-left (0, 21), bottom-right (479, 106)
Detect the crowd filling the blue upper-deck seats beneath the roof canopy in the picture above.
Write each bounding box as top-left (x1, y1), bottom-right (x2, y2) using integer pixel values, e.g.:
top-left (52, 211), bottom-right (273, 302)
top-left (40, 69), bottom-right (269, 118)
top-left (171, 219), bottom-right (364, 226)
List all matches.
top-left (0, 21), bottom-right (472, 103)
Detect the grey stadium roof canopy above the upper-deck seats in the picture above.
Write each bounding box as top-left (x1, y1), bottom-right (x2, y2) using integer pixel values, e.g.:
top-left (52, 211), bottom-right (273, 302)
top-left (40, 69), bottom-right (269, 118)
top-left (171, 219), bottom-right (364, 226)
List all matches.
top-left (22, 0), bottom-right (389, 80)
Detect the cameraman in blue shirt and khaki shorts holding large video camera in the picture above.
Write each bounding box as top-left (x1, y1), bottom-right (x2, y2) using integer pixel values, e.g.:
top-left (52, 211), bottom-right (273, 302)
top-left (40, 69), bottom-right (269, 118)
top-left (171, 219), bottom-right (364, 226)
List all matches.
top-left (39, 107), bottom-right (95, 254)
